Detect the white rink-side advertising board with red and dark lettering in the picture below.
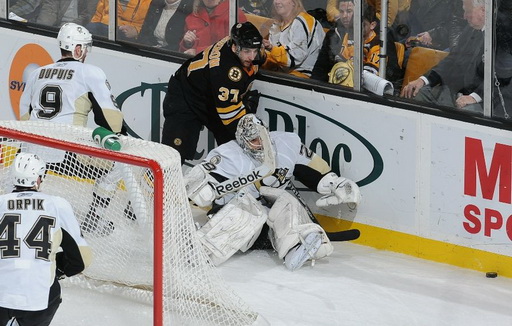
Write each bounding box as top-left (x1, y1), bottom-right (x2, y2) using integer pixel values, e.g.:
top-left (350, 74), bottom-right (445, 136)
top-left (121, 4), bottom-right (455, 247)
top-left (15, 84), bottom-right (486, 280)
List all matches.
top-left (0, 29), bottom-right (512, 262)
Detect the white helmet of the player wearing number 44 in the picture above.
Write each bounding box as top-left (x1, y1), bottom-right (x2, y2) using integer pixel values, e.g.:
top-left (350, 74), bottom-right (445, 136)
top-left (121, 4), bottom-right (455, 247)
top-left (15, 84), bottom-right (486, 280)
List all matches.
top-left (12, 153), bottom-right (46, 188)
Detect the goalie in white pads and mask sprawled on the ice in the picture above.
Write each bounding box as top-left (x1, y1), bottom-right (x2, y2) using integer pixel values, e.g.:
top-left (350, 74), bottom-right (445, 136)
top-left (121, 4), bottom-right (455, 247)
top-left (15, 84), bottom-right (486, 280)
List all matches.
top-left (185, 114), bottom-right (361, 270)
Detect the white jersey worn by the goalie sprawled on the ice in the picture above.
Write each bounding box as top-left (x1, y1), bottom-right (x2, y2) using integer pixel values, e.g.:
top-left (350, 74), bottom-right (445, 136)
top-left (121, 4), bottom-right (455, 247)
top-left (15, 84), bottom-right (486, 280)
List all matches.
top-left (205, 131), bottom-right (329, 204)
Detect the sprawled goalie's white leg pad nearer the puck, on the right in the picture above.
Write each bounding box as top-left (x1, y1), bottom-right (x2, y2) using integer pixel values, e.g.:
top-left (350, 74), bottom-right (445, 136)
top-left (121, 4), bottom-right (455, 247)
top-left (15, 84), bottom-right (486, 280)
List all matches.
top-left (260, 187), bottom-right (333, 259)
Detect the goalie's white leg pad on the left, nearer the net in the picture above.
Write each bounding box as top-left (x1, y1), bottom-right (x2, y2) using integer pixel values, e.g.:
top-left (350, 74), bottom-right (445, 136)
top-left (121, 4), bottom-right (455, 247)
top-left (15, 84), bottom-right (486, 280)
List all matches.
top-left (197, 192), bottom-right (267, 266)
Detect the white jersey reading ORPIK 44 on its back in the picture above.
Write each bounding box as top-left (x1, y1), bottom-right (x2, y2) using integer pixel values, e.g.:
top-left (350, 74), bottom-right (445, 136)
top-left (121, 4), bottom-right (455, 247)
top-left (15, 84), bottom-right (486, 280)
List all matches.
top-left (0, 191), bottom-right (91, 311)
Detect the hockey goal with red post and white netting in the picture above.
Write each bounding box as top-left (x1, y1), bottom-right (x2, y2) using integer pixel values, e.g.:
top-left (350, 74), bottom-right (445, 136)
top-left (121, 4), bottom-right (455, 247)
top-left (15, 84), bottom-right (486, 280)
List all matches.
top-left (0, 121), bottom-right (259, 326)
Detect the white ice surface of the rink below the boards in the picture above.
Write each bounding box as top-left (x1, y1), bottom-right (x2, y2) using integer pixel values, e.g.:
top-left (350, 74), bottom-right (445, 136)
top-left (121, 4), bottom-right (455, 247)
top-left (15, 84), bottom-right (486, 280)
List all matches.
top-left (52, 242), bottom-right (512, 326)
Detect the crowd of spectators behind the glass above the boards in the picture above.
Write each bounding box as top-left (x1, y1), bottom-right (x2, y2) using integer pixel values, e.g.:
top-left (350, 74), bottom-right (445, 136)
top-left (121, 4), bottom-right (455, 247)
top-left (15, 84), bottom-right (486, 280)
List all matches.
top-left (9, 0), bottom-right (510, 119)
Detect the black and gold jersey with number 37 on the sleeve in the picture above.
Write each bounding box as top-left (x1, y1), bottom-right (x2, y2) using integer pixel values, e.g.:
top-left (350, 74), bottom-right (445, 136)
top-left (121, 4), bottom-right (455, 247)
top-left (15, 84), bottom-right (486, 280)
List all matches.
top-left (175, 37), bottom-right (259, 137)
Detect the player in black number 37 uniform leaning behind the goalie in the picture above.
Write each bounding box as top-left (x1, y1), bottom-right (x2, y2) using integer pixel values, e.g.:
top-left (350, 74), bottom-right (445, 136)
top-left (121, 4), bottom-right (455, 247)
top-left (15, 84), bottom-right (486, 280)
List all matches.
top-left (162, 22), bottom-right (264, 164)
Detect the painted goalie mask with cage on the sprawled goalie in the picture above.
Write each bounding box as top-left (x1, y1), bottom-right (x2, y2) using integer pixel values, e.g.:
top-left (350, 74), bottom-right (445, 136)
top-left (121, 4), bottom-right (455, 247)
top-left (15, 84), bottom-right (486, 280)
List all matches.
top-left (235, 114), bottom-right (272, 162)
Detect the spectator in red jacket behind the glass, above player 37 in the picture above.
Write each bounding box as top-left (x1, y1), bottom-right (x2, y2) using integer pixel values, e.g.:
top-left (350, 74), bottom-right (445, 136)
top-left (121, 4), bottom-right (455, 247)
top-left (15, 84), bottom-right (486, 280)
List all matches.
top-left (180, 0), bottom-right (247, 55)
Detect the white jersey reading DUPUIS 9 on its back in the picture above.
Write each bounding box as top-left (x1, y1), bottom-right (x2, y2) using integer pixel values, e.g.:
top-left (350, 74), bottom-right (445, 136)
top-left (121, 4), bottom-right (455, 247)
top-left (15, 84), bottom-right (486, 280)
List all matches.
top-left (20, 58), bottom-right (123, 132)
